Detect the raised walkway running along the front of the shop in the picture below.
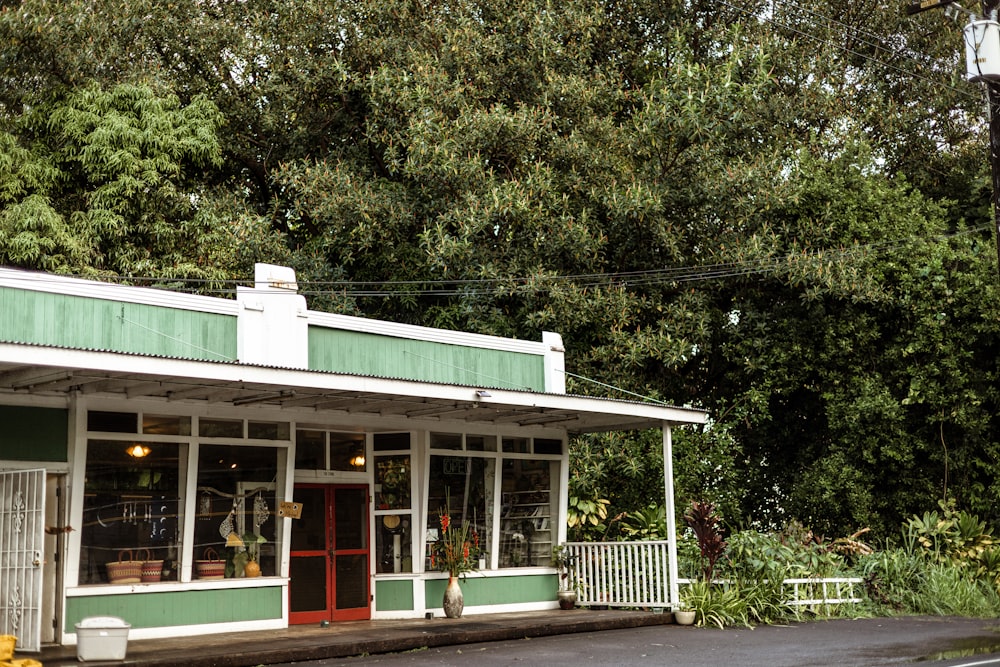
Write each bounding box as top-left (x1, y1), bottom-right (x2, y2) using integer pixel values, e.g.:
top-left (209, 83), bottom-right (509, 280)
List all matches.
top-left (35, 609), bottom-right (673, 667)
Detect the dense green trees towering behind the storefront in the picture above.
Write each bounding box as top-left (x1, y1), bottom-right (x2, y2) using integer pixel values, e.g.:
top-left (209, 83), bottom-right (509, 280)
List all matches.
top-left (0, 0), bottom-right (1000, 534)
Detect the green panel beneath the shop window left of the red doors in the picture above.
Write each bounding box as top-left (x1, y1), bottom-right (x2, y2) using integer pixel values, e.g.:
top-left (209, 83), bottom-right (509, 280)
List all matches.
top-left (65, 586), bottom-right (282, 632)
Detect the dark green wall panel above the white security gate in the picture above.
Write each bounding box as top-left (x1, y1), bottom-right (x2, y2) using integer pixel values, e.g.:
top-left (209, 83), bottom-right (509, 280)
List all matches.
top-left (0, 405), bottom-right (69, 463)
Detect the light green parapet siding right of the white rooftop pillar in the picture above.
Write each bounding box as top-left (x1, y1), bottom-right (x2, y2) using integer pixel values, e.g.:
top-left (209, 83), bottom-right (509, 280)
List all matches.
top-left (309, 327), bottom-right (545, 391)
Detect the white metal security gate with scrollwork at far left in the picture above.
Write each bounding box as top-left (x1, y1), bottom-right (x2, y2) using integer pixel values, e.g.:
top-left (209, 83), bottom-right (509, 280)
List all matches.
top-left (0, 470), bottom-right (45, 651)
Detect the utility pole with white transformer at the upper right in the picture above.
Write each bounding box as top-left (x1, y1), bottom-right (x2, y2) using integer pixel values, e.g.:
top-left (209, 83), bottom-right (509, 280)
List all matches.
top-left (906, 0), bottom-right (1000, 271)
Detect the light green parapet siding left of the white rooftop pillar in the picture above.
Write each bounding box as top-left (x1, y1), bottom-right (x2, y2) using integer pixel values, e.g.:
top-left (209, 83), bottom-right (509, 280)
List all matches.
top-left (0, 287), bottom-right (236, 361)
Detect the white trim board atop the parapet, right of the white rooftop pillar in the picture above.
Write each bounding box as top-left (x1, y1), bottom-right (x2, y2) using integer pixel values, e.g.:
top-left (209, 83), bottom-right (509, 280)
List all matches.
top-left (309, 310), bottom-right (548, 355)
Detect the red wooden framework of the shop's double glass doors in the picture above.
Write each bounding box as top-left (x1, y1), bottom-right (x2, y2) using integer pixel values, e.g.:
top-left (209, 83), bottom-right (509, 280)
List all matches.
top-left (288, 484), bottom-right (371, 625)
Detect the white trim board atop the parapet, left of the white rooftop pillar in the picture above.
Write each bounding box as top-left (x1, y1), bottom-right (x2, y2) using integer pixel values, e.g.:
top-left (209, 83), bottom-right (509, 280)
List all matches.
top-left (0, 267), bottom-right (239, 316)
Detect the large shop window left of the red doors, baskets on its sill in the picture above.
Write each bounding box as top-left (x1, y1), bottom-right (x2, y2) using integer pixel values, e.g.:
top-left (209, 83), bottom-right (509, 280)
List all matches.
top-left (77, 410), bottom-right (288, 585)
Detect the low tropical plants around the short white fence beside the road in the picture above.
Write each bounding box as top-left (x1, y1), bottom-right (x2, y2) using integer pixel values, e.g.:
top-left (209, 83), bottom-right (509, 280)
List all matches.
top-left (678, 502), bottom-right (1000, 627)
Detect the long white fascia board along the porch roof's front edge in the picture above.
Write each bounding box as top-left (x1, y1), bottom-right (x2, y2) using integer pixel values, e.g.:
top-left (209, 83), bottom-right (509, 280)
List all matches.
top-left (0, 343), bottom-right (707, 424)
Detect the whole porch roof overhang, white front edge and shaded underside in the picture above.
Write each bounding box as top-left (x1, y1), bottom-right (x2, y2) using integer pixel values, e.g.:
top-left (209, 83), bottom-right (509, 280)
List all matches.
top-left (0, 343), bottom-right (707, 433)
